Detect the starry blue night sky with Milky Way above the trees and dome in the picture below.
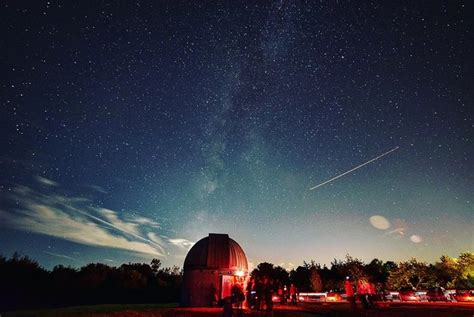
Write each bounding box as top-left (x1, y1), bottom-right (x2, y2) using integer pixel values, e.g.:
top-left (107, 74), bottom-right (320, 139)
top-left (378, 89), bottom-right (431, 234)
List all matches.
top-left (0, 0), bottom-right (474, 268)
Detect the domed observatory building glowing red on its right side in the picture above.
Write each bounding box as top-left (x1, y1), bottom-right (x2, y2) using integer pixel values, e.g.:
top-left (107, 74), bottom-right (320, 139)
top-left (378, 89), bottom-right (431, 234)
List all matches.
top-left (181, 233), bottom-right (248, 307)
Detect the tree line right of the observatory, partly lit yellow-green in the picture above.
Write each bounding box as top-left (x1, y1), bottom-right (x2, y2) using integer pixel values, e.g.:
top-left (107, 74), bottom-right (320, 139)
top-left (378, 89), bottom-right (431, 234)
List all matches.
top-left (250, 251), bottom-right (474, 292)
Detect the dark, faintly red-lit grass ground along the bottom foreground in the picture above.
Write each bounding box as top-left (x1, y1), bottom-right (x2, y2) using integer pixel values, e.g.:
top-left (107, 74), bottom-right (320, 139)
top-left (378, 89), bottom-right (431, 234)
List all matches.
top-left (0, 303), bottom-right (474, 317)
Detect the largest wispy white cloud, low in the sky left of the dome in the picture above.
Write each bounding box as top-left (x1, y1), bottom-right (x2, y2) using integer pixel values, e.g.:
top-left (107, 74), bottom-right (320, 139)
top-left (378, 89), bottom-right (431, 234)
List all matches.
top-left (0, 185), bottom-right (165, 256)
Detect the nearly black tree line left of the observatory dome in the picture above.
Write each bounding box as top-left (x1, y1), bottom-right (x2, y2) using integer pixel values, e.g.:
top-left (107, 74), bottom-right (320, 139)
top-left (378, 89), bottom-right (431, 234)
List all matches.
top-left (0, 254), bottom-right (182, 311)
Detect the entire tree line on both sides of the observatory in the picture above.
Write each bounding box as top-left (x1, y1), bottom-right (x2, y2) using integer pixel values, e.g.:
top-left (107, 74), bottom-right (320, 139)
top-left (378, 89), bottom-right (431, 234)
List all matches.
top-left (0, 251), bottom-right (474, 310)
